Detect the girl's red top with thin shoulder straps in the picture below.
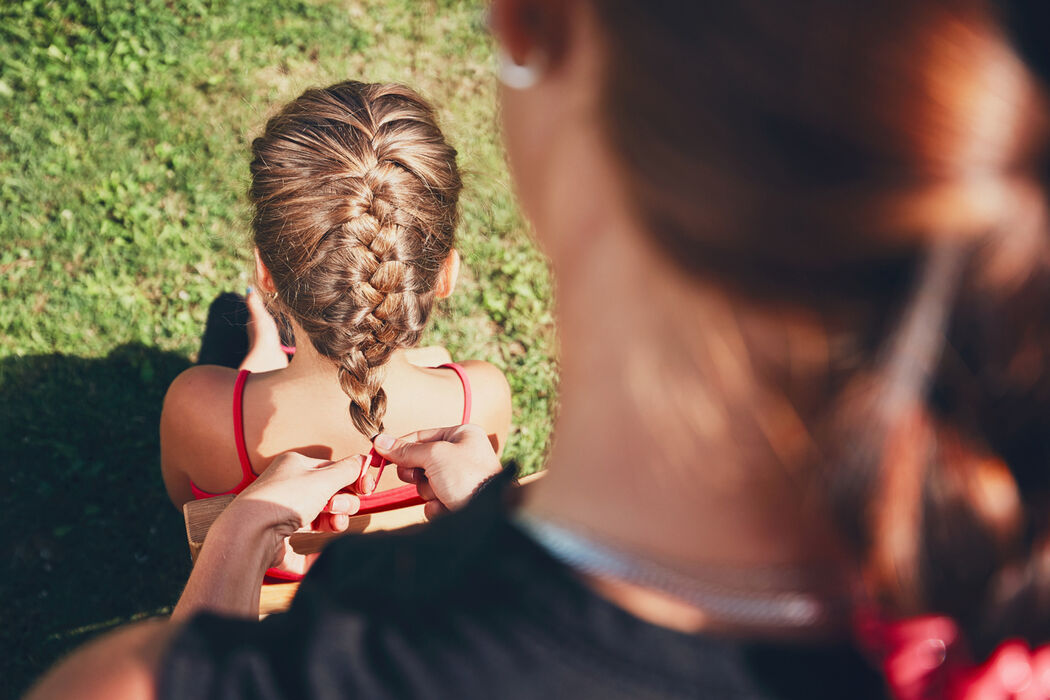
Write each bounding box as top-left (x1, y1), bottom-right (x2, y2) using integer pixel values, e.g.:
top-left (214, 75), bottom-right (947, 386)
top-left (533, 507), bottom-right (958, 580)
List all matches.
top-left (190, 362), bottom-right (470, 580)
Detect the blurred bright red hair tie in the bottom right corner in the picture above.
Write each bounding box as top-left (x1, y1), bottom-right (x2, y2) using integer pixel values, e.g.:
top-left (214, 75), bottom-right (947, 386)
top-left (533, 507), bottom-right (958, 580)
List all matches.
top-left (854, 611), bottom-right (1050, 700)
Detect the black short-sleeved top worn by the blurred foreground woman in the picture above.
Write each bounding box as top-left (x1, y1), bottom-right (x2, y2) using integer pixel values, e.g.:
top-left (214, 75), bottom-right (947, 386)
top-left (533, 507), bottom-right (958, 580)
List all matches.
top-left (159, 476), bottom-right (883, 700)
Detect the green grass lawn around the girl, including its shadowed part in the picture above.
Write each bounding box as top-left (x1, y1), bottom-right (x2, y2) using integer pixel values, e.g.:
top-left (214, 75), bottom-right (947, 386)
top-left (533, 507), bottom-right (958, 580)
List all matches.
top-left (0, 0), bottom-right (555, 697)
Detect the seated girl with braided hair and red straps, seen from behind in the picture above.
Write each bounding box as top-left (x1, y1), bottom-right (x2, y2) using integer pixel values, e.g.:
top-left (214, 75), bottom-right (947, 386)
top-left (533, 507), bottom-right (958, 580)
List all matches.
top-left (161, 82), bottom-right (510, 575)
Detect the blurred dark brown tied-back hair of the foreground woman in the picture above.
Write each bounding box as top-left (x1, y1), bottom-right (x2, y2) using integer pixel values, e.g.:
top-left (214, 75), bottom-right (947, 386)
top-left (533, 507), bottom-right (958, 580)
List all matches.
top-left (589, 0), bottom-right (1050, 649)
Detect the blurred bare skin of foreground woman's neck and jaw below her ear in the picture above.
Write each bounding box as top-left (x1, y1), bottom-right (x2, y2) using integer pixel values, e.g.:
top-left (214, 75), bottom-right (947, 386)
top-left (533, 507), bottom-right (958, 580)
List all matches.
top-left (504, 64), bottom-right (840, 629)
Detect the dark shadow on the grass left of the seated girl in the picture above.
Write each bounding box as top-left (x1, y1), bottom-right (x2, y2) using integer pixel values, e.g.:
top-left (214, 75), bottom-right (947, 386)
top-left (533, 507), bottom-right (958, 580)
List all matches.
top-left (0, 344), bottom-right (190, 697)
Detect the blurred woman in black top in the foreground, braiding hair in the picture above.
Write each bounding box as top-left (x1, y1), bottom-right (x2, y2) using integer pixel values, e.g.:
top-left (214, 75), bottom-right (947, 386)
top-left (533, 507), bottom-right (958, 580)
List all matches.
top-left (26, 0), bottom-right (1050, 698)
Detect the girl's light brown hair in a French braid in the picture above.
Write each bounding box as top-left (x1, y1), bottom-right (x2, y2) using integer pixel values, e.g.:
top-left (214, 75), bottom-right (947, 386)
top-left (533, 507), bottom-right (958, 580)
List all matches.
top-left (250, 82), bottom-right (461, 437)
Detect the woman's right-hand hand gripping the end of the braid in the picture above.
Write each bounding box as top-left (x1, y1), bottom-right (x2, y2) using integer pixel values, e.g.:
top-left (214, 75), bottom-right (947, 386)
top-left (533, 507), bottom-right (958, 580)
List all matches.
top-left (373, 425), bottom-right (502, 518)
